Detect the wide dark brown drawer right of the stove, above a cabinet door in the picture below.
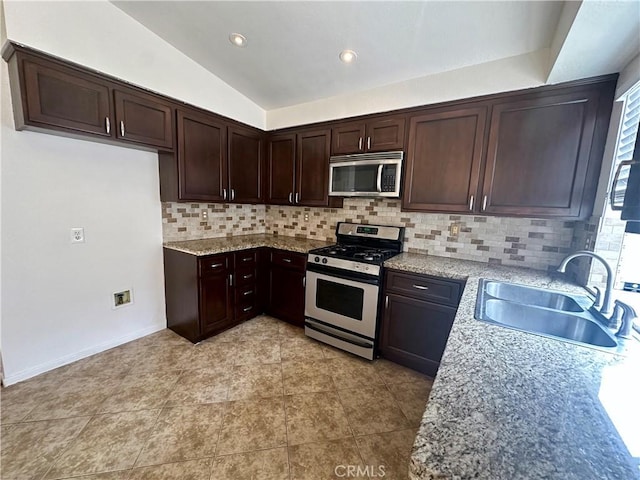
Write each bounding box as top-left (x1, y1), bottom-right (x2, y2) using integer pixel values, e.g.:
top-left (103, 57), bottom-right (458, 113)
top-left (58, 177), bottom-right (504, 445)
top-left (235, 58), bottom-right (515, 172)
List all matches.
top-left (385, 270), bottom-right (462, 306)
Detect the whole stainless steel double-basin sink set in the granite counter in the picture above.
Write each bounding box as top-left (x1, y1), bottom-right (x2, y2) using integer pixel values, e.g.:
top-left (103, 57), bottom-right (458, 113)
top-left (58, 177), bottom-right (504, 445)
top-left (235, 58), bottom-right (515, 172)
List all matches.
top-left (475, 279), bottom-right (618, 351)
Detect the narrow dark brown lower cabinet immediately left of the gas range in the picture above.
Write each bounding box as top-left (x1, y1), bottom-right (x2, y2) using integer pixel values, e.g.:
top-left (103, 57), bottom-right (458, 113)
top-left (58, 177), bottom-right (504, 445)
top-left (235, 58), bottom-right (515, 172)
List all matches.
top-left (267, 250), bottom-right (306, 327)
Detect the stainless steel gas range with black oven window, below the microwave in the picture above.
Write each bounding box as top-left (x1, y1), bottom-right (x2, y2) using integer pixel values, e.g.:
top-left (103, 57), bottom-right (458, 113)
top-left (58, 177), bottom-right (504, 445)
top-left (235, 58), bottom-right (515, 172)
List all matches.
top-left (304, 222), bottom-right (404, 360)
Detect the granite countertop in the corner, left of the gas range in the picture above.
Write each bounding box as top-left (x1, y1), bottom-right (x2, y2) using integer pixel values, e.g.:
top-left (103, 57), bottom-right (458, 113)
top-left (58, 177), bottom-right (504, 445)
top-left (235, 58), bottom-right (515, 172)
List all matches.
top-left (164, 234), bottom-right (335, 256)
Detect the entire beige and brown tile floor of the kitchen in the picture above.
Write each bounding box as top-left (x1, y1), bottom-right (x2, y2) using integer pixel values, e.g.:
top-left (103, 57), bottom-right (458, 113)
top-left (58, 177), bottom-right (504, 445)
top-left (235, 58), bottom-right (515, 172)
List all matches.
top-left (0, 316), bottom-right (431, 480)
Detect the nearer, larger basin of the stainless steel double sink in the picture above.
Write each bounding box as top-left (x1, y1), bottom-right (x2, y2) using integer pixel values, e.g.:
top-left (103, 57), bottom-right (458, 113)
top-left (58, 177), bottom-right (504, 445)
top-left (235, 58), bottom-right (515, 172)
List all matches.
top-left (482, 299), bottom-right (617, 348)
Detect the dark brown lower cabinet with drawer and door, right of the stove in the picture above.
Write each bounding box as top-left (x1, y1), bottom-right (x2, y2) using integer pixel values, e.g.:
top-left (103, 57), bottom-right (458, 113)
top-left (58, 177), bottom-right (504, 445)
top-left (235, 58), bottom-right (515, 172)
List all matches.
top-left (380, 271), bottom-right (462, 377)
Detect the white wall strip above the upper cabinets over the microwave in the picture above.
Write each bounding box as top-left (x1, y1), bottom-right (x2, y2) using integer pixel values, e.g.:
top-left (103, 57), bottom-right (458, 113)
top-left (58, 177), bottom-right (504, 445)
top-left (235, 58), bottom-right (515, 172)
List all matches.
top-left (267, 49), bottom-right (549, 130)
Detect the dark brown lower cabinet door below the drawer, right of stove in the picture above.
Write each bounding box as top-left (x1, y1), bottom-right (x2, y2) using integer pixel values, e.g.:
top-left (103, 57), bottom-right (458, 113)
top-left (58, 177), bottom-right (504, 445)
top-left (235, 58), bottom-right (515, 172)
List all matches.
top-left (381, 294), bottom-right (456, 377)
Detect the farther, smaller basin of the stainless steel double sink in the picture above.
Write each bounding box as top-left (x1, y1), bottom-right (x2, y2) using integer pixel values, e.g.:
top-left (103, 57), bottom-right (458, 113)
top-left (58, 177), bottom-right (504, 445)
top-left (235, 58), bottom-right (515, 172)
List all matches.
top-left (483, 281), bottom-right (585, 312)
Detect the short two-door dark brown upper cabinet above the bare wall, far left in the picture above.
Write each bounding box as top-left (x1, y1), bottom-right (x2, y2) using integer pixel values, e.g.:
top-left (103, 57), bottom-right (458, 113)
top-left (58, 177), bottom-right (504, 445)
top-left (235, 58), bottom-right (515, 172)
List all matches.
top-left (4, 44), bottom-right (175, 150)
